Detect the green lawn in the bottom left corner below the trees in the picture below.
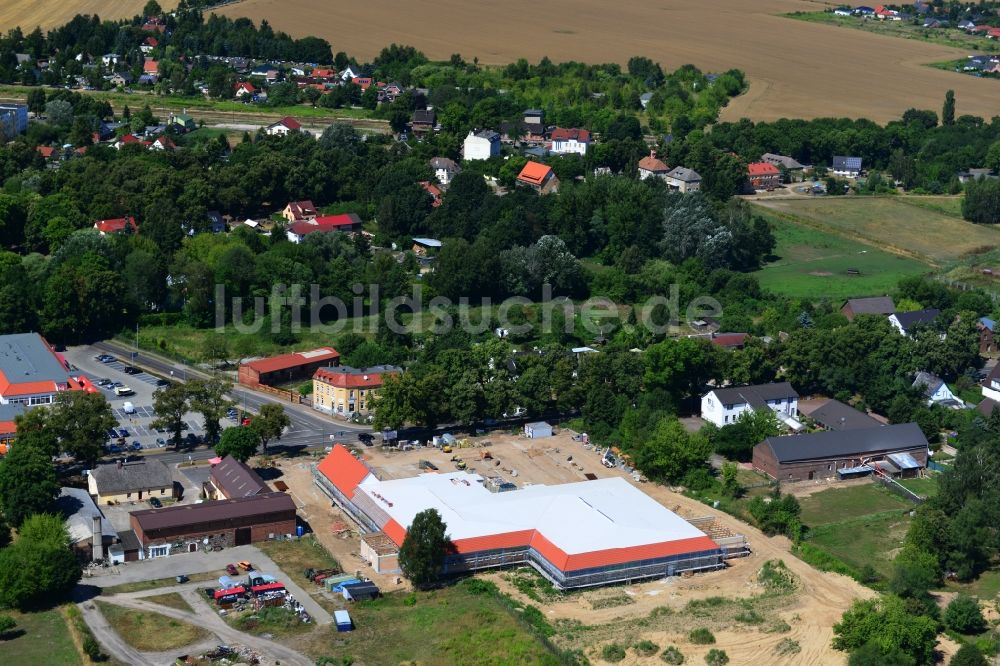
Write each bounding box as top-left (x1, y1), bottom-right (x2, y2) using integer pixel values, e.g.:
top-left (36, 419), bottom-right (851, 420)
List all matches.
top-left (0, 608), bottom-right (84, 666)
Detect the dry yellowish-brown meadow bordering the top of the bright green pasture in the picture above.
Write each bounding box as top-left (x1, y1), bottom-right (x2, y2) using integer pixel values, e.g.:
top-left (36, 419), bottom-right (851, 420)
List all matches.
top-left (757, 196), bottom-right (1000, 267)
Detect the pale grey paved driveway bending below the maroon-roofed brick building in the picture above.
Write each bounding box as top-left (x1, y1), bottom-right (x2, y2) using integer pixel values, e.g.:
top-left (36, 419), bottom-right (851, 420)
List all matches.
top-left (81, 546), bottom-right (333, 624)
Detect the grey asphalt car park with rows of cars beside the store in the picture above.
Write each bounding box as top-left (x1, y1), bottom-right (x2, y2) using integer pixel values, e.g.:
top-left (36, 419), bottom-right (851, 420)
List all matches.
top-left (65, 346), bottom-right (205, 453)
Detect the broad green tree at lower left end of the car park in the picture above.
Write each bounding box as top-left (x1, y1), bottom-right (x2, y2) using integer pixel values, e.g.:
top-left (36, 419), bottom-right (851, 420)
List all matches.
top-left (49, 391), bottom-right (118, 467)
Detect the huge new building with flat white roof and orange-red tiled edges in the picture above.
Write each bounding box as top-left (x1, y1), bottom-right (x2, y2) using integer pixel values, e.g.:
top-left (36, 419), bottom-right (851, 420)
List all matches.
top-left (313, 445), bottom-right (747, 589)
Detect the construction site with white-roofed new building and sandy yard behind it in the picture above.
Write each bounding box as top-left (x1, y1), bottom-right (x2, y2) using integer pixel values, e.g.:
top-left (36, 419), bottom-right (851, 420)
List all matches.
top-left (304, 426), bottom-right (749, 589)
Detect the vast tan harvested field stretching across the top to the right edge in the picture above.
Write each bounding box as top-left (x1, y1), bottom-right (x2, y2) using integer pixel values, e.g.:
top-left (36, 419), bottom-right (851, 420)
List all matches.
top-left (217, 0), bottom-right (1000, 122)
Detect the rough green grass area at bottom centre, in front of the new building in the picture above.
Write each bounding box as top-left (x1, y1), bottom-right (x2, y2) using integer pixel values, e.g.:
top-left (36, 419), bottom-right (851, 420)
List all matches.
top-left (299, 583), bottom-right (559, 666)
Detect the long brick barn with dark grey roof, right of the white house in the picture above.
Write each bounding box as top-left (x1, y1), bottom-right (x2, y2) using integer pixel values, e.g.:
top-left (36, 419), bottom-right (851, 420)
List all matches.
top-left (753, 423), bottom-right (927, 481)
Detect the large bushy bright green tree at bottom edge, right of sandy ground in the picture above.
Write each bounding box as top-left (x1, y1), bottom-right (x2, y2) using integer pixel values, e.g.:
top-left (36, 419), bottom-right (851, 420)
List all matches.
top-left (833, 595), bottom-right (937, 664)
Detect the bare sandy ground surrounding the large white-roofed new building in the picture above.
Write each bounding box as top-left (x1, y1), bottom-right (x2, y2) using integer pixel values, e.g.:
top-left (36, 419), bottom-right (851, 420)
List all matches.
top-left (279, 433), bottom-right (874, 664)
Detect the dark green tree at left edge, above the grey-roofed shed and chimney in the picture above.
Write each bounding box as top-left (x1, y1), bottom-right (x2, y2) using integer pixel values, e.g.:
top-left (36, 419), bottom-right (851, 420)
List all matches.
top-left (0, 439), bottom-right (59, 527)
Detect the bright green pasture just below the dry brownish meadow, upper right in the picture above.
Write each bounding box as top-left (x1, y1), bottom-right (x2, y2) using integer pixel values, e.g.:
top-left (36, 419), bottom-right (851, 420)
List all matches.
top-left (755, 208), bottom-right (929, 300)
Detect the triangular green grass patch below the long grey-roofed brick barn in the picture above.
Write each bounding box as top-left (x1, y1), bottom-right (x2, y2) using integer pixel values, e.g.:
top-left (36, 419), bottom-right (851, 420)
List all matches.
top-left (808, 508), bottom-right (913, 576)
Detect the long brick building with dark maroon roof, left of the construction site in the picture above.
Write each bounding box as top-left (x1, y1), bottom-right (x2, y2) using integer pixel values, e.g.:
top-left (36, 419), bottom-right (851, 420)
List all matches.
top-left (129, 493), bottom-right (295, 557)
